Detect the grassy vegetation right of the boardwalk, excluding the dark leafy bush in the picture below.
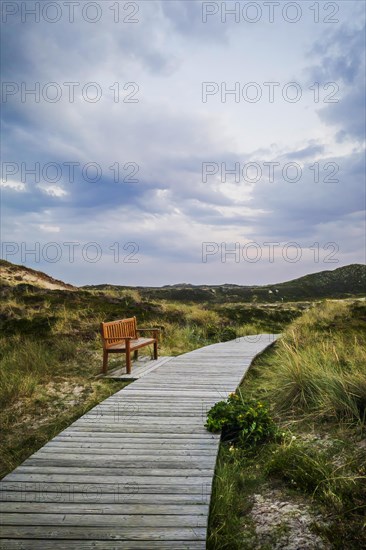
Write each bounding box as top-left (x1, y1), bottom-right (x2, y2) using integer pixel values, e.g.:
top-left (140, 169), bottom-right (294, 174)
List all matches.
top-left (209, 301), bottom-right (366, 549)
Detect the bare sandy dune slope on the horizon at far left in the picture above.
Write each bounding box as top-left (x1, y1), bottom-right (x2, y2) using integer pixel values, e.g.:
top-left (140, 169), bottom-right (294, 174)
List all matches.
top-left (0, 260), bottom-right (76, 290)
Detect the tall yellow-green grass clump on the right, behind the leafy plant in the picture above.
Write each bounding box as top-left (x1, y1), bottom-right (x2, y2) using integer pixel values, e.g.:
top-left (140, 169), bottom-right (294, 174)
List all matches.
top-left (269, 302), bottom-right (366, 423)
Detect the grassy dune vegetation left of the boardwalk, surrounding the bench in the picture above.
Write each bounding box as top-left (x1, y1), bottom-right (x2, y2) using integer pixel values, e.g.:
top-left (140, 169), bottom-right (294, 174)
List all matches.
top-left (0, 261), bottom-right (309, 476)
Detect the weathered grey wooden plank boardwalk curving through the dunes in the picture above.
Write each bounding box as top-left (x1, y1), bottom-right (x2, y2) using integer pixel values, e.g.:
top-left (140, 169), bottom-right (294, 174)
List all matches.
top-left (0, 335), bottom-right (276, 550)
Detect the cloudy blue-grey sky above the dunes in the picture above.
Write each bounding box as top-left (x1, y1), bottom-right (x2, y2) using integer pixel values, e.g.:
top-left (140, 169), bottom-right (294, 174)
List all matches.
top-left (1, 0), bottom-right (365, 286)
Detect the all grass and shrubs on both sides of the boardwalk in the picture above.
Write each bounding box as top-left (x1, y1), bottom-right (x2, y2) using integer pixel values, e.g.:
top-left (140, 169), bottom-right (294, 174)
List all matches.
top-left (0, 264), bottom-right (366, 550)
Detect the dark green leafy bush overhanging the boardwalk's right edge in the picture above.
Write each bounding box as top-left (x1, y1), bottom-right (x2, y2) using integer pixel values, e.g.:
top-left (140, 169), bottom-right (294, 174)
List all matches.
top-left (205, 391), bottom-right (277, 446)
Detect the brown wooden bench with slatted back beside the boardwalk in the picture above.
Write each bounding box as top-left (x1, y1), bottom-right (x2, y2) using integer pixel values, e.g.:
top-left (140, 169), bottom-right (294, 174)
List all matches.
top-left (100, 317), bottom-right (159, 374)
